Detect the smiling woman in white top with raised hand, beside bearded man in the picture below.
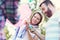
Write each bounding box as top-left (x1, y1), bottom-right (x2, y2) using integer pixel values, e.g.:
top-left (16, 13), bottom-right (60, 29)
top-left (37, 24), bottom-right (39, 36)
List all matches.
top-left (26, 12), bottom-right (44, 40)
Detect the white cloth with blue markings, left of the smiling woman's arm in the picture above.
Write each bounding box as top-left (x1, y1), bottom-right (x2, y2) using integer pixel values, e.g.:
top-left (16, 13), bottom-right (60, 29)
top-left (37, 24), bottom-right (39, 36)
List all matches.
top-left (13, 25), bottom-right (28, 40)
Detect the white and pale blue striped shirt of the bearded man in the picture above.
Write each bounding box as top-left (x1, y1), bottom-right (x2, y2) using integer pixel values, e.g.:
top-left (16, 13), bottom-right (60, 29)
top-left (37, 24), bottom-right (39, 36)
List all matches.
top-left (45, 12), bottom-right (60, 40)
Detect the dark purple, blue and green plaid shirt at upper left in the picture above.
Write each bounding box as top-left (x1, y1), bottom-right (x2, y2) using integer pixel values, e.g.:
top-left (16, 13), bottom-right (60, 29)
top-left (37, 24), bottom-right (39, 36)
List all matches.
top-left (0, 0), bottom-right (19, 24)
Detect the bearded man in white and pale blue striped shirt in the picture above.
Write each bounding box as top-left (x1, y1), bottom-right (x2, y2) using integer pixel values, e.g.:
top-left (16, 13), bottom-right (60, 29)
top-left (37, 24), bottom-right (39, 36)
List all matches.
top-left (39, 0), bottom-right (60, 40)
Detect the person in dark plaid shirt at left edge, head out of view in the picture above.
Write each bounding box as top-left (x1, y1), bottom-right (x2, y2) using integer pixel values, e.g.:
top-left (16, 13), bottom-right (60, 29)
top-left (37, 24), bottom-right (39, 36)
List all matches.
top-left (0, 0), bottom-right (19, 40)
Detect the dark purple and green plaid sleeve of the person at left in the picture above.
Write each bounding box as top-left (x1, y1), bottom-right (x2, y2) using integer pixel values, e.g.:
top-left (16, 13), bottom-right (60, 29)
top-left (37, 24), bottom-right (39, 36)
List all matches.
top-left (5, 0), bottom-right (19, 24)
